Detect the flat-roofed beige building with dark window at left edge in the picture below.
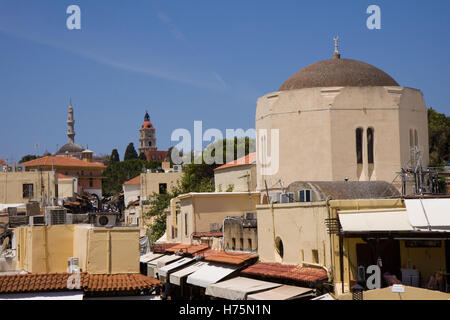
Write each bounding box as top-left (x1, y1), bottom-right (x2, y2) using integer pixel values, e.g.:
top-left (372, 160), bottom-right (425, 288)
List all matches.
top-left (0, 171), bottom-right (58, 207)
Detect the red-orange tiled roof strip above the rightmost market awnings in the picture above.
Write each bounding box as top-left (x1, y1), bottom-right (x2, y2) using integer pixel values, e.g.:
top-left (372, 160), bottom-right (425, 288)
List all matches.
top-left (241, 262), bottom-right (328, 283)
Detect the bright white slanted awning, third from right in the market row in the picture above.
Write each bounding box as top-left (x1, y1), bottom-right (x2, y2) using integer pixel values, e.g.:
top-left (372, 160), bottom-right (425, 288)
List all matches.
top-left (186, 263), bottom-right (239, 288)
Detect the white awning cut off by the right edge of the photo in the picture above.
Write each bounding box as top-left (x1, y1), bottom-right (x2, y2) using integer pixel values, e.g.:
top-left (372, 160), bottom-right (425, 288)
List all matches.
top-left (405, 199), bottom-right (450, 231)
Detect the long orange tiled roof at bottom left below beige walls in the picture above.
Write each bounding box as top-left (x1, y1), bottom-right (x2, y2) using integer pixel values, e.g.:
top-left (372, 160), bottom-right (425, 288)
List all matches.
top-left (0, 273), bottom-right (161, 295)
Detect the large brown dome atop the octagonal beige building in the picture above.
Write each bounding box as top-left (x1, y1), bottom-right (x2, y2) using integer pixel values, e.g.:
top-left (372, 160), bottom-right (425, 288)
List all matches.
top-left (278, 58), bottom-right (399, 91)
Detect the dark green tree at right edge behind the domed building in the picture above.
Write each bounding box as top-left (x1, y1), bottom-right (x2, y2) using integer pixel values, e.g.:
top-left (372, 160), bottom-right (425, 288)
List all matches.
top-left (428, 108), bottom-right (450, 167)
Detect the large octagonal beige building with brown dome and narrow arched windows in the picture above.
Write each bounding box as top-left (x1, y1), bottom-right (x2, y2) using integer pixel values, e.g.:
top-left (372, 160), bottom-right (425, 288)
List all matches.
top-left (255, 44), bottom-right (429, 190)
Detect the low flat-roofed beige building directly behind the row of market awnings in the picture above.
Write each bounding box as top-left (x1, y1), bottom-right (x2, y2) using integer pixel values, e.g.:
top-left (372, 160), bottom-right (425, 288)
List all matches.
top-left (166, 192), bottom-right (260, 243)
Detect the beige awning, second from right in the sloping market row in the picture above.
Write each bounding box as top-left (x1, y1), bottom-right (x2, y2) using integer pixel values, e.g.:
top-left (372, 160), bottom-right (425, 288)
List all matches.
top-left (205, 277), bottom-right (281, 300)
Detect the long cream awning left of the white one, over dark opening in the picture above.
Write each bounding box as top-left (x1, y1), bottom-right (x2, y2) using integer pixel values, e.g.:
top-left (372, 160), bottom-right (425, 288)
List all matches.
top-left (338, 209), bottom-right (414, 232)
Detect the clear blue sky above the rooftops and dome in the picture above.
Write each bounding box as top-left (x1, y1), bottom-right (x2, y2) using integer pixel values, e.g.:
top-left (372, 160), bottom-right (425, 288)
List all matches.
top-left (0, 0), bottom-right (450, 161)
